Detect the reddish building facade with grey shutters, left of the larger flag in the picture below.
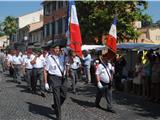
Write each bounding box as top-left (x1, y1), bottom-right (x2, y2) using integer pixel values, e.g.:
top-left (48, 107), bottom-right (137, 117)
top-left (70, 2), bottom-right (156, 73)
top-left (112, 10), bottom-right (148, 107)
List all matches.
top-left (42, 1), bottom-right (67, 44)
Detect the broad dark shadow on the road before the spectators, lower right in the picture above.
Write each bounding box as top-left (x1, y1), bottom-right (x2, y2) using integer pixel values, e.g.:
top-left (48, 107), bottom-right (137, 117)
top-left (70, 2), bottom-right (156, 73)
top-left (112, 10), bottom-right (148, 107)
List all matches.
top-left (113, 91), bottom-right (160, 119)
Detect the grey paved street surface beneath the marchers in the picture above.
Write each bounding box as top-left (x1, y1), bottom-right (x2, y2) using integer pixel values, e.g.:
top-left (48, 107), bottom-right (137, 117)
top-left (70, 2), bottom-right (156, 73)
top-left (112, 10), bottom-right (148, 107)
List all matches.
top-left (0, 73), bottom-right (160, 120)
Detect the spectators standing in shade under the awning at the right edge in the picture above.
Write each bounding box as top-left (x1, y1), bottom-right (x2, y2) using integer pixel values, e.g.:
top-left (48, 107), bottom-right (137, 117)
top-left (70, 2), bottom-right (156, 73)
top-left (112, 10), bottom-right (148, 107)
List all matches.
top-left (133, 50), bottom-right (160, 102)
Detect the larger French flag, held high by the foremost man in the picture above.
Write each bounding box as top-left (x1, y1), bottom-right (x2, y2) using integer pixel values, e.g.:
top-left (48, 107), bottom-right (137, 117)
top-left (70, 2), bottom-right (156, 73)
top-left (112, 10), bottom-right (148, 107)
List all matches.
top-left (66, 0), bottom-right (82, 57)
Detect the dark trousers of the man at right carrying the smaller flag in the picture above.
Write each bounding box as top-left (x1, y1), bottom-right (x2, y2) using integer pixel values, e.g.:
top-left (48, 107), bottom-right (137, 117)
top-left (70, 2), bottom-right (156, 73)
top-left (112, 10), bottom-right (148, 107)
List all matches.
top-left (95, 83), bottom-right (112, 110)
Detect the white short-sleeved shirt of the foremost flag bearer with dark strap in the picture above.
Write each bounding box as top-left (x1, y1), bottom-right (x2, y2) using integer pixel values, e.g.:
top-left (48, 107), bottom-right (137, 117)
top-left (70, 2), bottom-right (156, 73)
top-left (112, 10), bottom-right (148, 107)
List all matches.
top-left (45, 55), bottom-right (65, 77)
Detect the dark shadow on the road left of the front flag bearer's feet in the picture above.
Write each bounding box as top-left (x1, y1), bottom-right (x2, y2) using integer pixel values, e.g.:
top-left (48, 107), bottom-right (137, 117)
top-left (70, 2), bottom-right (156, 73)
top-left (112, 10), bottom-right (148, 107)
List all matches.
top-left (26, 102), bottom-right (56, 120)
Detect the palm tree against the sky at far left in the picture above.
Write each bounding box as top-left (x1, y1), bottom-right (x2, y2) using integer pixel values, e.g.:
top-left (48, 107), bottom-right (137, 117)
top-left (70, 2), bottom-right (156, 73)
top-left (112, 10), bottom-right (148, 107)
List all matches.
top-left (3, 16), bottom-right (18, 40)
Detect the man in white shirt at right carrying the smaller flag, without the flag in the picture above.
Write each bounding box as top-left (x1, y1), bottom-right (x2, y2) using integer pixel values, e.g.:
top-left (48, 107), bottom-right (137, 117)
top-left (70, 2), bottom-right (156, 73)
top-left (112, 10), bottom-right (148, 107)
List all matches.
top-left (95, 56), bottom-right (115, 113)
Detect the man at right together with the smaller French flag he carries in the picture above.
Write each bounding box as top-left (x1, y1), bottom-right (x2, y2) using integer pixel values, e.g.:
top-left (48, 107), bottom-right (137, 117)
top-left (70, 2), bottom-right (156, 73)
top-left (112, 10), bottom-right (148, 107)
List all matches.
top-left (95, 18), bottom-right (117, 113)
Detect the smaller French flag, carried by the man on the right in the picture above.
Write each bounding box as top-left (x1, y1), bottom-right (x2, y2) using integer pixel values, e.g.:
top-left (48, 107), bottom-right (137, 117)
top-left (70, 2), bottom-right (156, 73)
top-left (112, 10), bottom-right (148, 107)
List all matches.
top-left (106, 17), bottom-right (117, 53)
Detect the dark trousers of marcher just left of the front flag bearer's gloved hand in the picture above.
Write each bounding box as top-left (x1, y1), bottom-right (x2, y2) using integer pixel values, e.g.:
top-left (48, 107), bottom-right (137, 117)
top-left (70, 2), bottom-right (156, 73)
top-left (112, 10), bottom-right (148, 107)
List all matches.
top-left (32, 68), bottom-right (44, 92)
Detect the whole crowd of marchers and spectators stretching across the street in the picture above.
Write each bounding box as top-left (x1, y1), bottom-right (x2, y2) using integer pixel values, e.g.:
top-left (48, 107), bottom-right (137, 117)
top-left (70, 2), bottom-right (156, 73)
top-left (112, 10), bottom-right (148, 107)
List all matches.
top-left (0, 44), bottom-right (160, 120)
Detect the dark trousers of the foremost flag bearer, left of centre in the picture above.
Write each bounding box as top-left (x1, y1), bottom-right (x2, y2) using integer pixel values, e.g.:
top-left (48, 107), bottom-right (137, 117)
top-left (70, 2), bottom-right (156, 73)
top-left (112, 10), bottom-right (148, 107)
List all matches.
top-left (49, 75), bottom-right (67, 120)
